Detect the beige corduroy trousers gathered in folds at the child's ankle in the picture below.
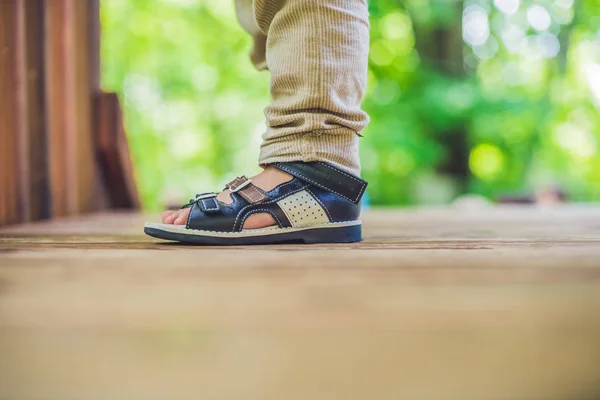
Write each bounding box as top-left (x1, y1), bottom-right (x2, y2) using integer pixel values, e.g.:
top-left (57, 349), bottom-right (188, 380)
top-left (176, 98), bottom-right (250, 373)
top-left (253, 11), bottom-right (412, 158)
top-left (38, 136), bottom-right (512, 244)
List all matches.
top-left (236, 0), bottom-right (369, 175)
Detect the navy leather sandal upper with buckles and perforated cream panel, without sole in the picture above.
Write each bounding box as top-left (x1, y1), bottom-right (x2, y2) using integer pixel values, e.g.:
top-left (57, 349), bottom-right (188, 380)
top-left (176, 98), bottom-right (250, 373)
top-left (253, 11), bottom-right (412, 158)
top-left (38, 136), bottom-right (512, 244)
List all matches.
top-left (186, 162), bottom-right (367, 232)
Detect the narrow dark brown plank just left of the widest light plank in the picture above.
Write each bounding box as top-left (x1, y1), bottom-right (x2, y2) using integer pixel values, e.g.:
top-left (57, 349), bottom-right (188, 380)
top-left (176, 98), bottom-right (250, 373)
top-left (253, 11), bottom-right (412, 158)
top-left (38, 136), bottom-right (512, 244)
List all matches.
top-left (21, 0), bottom-right (51, 221)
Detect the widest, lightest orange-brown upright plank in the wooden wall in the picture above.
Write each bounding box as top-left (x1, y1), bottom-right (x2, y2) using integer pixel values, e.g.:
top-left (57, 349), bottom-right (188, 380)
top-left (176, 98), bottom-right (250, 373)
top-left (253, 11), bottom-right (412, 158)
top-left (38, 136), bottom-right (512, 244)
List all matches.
top-left (45, 0), bottom-right (97, 216)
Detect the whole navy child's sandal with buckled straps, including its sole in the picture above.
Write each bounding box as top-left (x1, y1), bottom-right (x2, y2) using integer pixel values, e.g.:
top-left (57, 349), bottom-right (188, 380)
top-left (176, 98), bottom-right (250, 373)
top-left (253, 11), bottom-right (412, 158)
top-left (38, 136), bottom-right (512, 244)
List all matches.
top-left (144, 162), bottom-right (367, 245)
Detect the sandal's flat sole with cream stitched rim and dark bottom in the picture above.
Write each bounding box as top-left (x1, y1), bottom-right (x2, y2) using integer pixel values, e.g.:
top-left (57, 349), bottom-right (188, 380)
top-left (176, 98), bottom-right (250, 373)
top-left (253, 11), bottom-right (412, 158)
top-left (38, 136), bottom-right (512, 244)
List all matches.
top-left (144, 221), bottom-right (362, 246)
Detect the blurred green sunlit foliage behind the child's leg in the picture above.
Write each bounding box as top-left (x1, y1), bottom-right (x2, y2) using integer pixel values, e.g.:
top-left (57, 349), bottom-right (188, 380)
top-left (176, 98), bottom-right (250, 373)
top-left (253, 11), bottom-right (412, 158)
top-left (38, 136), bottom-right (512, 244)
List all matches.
top-left (100, 0), bottom-right (600, 210)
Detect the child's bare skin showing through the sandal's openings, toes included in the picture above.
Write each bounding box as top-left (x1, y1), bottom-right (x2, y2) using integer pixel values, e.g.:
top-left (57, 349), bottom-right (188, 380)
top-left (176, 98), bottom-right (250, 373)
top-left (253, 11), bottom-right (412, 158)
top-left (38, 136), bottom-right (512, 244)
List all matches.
top-left (162, 166), bottom-right (292, 229)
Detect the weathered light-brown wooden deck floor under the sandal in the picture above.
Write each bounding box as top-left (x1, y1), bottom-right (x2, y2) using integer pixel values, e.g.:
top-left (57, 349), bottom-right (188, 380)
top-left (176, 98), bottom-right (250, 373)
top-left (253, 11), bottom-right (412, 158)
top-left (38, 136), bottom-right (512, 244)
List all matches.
top-left (0, 206), bottom-right (600, 400)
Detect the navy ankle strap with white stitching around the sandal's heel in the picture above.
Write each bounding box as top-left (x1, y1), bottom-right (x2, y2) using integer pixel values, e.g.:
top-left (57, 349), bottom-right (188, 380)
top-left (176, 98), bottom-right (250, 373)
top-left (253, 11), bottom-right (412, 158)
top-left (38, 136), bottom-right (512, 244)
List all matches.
top-left (272, 161), bottom-right (367, 204)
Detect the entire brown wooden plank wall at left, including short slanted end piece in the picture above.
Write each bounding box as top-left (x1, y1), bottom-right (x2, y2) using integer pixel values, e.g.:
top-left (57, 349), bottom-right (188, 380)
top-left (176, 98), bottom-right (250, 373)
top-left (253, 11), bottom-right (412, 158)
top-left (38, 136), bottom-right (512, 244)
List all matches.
top-left (0, 0), bottom-right (139, 225)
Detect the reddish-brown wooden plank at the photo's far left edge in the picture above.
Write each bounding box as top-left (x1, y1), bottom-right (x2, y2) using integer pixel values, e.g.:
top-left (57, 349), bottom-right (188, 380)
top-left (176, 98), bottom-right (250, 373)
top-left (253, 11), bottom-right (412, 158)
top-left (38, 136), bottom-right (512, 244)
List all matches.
top-left (0, 0), bottom-right (22, 225)
